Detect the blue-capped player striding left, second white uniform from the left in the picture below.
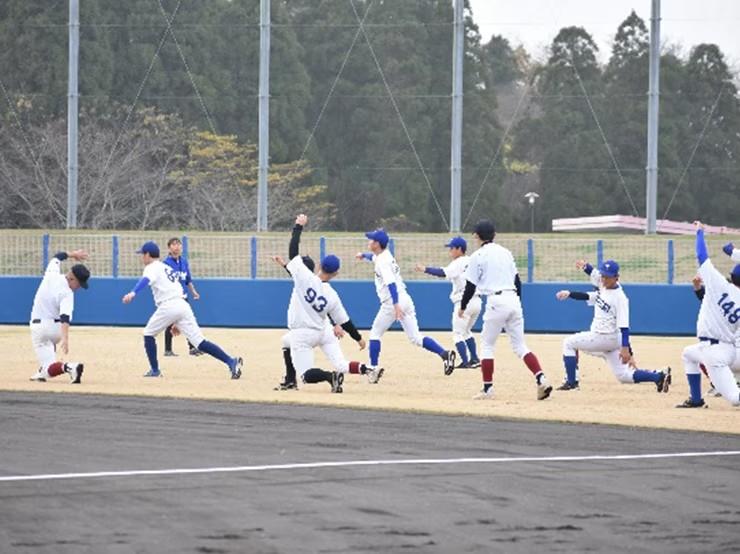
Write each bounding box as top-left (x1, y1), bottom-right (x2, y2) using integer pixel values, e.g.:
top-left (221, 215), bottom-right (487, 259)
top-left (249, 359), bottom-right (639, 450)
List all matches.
top-left (123, 241), bottom-right (244, 379)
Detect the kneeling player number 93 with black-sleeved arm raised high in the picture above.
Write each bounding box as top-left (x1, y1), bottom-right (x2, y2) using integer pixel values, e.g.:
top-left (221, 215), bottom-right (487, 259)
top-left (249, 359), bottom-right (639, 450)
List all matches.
top-left (273, 214), bottom-right (382, 393)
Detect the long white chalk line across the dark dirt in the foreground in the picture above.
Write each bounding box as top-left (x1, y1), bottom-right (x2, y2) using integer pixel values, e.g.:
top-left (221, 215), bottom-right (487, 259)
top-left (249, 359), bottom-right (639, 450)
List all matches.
top-left (0, 450), bottom-right (740, 483)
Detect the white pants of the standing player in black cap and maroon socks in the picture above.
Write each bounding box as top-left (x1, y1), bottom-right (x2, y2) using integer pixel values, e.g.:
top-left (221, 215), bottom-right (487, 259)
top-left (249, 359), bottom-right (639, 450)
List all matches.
top-left (481, 290), bottom-right (530, 359)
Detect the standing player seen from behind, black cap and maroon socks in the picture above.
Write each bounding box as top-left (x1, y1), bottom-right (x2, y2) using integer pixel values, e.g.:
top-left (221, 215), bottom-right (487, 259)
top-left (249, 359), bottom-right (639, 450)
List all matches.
top-left (458, 220), bottom-right (552, 400)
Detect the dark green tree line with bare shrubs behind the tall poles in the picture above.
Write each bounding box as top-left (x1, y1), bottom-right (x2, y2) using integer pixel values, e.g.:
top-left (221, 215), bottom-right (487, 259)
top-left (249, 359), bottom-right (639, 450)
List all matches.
top-left (0, 0), bottom-right (740, 231)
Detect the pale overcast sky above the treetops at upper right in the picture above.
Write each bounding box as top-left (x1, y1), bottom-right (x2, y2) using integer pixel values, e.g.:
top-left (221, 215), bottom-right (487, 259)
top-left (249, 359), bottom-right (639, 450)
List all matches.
top-left (470, 0), bottom-right (740, 70)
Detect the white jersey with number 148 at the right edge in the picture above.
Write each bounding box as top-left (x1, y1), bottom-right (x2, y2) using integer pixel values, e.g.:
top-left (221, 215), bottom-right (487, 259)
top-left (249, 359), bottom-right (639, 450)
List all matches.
top-left (696, 259), bottom-right (740, 344)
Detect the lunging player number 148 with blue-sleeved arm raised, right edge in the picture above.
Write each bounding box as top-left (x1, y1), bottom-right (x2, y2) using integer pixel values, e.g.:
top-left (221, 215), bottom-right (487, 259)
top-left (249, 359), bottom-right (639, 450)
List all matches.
top-left (676, 222), bottom-right (740, 408)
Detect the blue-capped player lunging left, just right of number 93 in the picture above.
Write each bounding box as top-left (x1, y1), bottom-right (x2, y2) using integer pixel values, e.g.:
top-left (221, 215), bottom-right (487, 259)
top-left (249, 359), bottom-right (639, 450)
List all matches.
top-left (356, 229), bottom-right (455, 375)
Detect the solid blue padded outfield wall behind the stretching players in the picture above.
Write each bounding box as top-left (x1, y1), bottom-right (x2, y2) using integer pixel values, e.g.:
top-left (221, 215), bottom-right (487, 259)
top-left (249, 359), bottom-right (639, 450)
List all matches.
top-left (0, 277), bottom-right (699, 335)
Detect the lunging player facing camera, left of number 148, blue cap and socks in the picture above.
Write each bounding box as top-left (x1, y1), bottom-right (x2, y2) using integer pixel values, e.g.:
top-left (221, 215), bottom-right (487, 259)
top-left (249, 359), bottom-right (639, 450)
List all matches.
top-left (556, 260), bottom-right (671, 392)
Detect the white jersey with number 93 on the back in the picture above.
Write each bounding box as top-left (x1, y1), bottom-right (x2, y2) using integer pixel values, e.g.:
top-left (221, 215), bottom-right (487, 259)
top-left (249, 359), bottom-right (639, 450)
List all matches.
top-left (285, 256), bottom-right (349, 330)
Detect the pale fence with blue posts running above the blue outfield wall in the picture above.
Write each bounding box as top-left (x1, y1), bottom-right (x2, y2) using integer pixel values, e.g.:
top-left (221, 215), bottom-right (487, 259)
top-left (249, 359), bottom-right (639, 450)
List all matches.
top-left (0, 232), bottom-right (740, 284)
